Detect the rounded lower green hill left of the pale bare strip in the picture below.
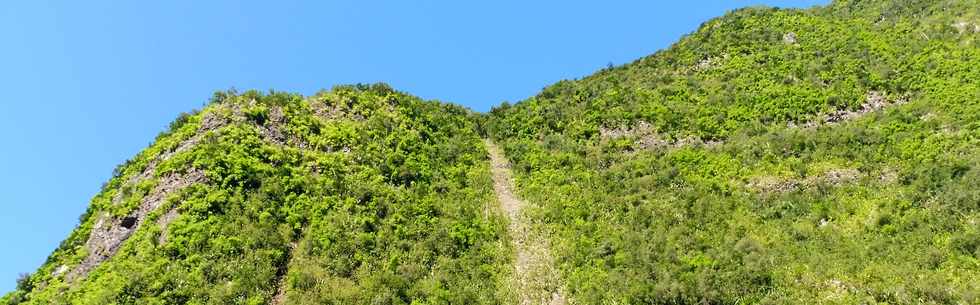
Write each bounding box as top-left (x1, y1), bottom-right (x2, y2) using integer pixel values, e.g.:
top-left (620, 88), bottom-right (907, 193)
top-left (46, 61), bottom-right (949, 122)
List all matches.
top-left (2, 85), bottom-right (509, 304)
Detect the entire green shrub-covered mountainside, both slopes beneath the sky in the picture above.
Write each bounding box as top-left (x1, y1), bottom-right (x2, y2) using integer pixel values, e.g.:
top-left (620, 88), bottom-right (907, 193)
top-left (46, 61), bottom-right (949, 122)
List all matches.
top-left (0, 0), bottom-right (980, 305)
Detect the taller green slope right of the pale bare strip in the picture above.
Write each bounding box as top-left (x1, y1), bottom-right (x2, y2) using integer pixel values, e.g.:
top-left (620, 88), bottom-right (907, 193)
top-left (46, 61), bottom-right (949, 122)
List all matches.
top-left (486, 0), bottom-right (980, 304)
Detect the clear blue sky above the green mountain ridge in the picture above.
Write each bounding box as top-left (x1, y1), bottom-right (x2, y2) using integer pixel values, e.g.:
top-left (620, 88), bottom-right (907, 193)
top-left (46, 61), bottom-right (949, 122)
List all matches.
top-left (0, 0), bottom-right (826, 294)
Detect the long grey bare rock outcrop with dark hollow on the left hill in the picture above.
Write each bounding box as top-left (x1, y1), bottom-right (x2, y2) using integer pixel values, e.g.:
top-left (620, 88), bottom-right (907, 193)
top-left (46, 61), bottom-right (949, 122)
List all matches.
top-left (66, 169), bottom-right (205, 282)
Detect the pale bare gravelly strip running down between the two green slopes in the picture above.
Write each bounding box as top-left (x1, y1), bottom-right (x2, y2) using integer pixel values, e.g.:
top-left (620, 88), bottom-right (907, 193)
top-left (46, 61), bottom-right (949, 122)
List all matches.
top-left (485, 140), bottom-right (568, 305)
